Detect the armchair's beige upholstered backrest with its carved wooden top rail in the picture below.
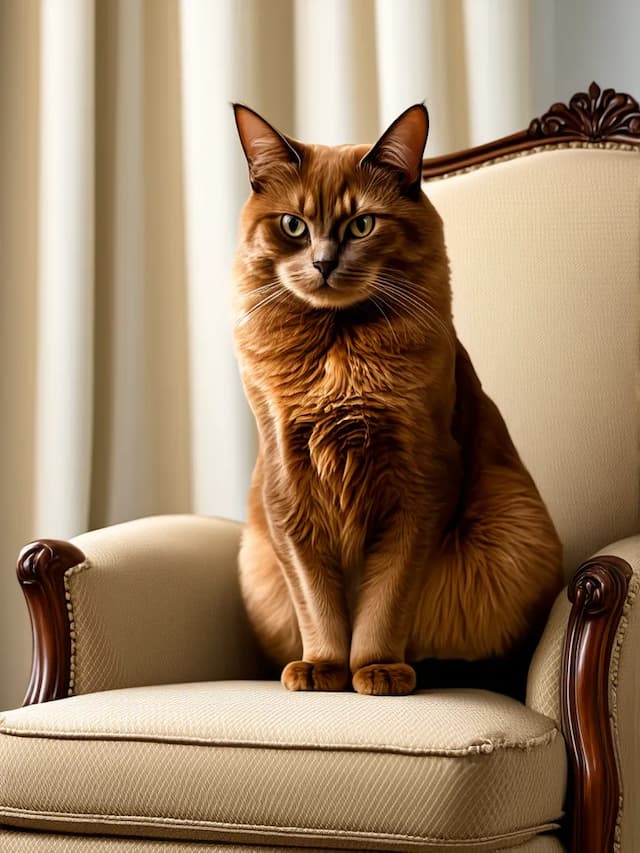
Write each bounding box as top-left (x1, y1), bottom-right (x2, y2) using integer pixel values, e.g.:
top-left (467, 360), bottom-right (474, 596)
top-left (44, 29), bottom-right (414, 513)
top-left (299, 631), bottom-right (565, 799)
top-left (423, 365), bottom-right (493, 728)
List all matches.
top-left (424, 86), bottom-right (640, 573)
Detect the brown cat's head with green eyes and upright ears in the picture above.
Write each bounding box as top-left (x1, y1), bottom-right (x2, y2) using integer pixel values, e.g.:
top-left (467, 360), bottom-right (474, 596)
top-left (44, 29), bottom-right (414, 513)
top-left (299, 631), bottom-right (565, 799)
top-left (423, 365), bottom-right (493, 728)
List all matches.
top-left (234, 104), bottom-right (442, 308)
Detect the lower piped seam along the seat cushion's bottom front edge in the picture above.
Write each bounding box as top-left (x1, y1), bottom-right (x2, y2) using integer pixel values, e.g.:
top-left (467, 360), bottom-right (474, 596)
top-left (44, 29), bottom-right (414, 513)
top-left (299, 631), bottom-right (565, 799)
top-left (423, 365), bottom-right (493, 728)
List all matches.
top-left (0, 806), bottom-right (560, 846)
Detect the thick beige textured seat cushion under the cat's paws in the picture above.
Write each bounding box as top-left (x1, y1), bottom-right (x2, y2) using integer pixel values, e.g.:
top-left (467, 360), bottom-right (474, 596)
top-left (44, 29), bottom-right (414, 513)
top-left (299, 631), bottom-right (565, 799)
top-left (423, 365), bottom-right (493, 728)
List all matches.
top-left (0, 681), bottom-right (566, 851)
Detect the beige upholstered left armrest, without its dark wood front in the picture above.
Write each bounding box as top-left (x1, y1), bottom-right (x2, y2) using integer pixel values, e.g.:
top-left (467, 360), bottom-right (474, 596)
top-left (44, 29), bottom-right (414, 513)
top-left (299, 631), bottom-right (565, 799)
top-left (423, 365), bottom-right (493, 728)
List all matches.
top-left (66, 515), bottom-right (258, 693)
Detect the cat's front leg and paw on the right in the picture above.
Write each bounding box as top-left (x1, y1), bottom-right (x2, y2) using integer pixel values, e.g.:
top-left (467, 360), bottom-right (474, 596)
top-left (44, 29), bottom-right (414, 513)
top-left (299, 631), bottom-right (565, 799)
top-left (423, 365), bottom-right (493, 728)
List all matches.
top-left (350, 526), bottom-right (419, 696)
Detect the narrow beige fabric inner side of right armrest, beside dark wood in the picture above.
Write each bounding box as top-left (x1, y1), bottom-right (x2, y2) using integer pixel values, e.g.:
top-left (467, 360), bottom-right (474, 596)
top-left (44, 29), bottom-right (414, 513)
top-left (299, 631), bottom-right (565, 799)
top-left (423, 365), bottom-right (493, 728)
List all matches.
top-left (527, 587), bottom-right (571, 726)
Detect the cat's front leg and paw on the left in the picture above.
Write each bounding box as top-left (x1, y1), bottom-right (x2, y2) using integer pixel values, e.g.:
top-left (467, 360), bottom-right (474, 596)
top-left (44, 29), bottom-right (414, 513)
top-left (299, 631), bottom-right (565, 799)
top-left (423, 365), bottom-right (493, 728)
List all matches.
top-left (270, 535), bottom-right (350, 690)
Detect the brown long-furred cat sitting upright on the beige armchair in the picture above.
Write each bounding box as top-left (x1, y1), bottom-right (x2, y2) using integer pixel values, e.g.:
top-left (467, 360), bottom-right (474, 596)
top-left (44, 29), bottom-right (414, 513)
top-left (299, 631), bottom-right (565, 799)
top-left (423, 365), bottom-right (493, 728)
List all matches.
top-left (234, 104), bottom-right (562, 695)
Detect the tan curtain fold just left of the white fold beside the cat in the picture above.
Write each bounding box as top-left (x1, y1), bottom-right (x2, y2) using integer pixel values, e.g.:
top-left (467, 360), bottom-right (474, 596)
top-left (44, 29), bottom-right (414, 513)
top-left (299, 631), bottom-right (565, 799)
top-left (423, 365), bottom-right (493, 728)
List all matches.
top-left (141, 0), bottom-right (194, 515)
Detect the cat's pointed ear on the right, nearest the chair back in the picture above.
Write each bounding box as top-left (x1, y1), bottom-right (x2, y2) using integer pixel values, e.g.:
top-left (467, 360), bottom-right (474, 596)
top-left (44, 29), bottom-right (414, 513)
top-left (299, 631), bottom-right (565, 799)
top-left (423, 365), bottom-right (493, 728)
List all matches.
top-left (360, 104), bottom-right (429, 191)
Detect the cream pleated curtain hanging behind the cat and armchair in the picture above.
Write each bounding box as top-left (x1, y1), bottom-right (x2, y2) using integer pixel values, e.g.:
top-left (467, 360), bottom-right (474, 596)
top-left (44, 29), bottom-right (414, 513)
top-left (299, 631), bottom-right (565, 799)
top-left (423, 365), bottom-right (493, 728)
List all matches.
top-left (0, 0), bottom-right (534, 707)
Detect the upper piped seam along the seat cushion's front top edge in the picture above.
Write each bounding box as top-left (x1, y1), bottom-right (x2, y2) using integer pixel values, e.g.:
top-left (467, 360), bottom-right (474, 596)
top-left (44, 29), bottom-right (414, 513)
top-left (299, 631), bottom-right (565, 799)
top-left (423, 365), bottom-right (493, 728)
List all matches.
top-left (0, 725), bottom-right (558, 758)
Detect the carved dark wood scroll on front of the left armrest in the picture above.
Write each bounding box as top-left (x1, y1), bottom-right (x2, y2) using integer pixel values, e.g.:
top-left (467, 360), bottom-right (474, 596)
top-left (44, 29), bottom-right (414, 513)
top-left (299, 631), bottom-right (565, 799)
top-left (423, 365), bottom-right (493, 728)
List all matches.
top-left (17, 539), bottom-right (85, 705)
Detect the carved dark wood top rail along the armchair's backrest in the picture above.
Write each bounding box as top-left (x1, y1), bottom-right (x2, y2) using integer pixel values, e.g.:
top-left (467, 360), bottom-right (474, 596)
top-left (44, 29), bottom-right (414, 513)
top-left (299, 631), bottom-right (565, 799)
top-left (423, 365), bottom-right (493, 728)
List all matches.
top-left (422, 83), bottom-right (640, 181)
